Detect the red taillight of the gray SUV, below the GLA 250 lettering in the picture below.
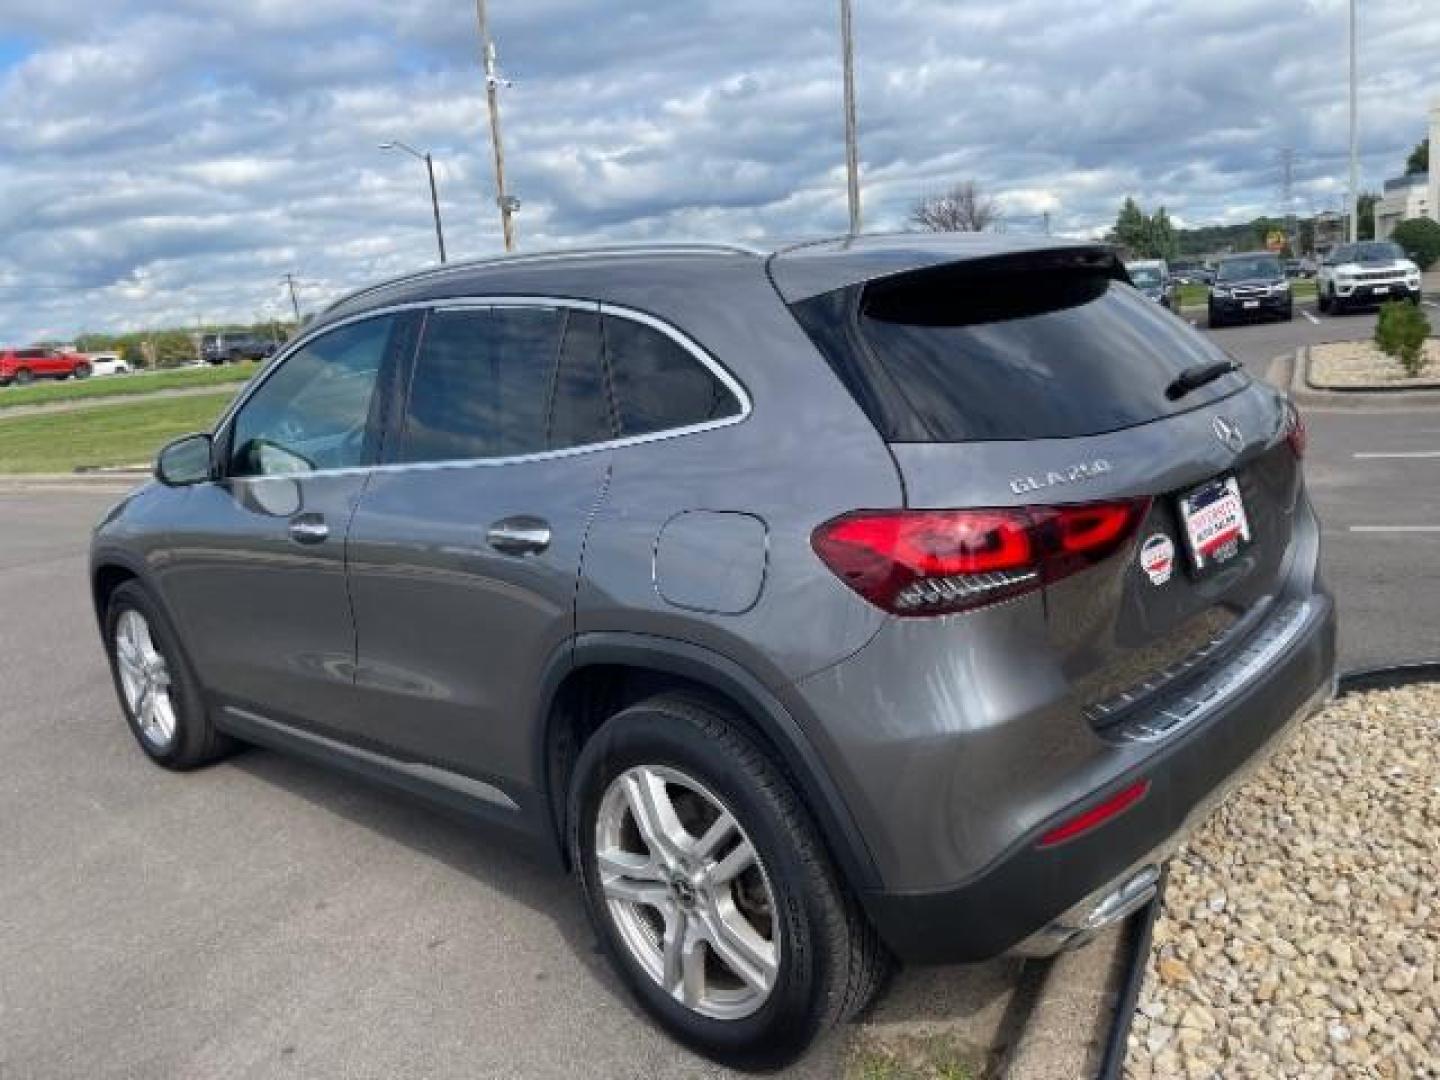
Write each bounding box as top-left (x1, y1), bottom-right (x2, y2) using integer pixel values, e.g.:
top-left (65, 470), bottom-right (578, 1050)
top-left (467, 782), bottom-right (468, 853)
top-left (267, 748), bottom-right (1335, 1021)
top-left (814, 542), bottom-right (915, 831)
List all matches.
top-left (811, 498), bottom-right (1149, 615)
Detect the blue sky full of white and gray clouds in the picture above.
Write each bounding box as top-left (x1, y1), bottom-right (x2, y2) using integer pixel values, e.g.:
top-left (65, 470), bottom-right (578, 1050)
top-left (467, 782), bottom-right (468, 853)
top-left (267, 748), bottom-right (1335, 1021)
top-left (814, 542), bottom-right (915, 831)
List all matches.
top-left (0, 0), bottom-right (1440, 341)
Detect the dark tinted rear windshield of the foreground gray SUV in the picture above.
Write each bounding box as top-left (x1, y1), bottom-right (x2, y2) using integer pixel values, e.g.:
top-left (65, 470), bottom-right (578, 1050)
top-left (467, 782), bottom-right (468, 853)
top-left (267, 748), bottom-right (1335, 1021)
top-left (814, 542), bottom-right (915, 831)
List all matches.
top-left (796, 268), bottom-right (1243, 442)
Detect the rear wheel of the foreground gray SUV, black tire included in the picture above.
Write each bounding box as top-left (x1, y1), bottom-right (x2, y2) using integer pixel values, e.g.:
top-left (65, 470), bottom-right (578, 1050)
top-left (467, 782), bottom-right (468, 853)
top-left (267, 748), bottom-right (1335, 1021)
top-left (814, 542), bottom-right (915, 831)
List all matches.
top-left (567, 694), bottom-right (890, 1068)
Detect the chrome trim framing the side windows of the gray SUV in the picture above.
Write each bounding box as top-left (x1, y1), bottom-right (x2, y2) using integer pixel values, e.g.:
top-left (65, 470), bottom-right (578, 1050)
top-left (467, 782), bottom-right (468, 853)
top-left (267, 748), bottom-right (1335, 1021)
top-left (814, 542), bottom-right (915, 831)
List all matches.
top-left (213, 295), bottom-right (753, 481)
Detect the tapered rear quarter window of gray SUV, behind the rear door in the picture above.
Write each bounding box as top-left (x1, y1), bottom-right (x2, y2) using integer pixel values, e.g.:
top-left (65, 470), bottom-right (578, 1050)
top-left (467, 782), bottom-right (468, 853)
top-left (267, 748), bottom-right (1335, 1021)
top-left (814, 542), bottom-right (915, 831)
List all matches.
top-left (605, 315), bottom-right (740, 436)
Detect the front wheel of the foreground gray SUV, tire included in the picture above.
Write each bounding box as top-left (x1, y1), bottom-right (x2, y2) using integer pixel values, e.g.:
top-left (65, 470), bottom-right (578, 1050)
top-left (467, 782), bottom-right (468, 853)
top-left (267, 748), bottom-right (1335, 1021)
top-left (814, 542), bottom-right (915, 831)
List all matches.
top-left (105, 580), bottom-right (235, 770)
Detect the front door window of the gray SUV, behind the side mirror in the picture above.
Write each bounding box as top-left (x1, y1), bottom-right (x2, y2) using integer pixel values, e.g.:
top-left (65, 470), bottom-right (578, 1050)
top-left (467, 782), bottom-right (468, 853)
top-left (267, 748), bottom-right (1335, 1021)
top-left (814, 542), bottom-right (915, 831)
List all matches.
top-left (228, 315), bottom-right (396, 477)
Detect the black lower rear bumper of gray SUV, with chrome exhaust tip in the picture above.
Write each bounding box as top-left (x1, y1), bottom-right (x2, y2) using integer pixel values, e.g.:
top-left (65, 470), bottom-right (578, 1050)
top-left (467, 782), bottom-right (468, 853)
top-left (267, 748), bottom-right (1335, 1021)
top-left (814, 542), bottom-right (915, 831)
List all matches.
top-left (863, 593), bottom-right (1335, 963)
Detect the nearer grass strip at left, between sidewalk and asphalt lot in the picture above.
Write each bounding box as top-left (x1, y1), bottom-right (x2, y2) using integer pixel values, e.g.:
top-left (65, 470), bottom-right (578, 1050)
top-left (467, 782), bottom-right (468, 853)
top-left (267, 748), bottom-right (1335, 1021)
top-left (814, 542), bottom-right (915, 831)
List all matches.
top-left (0, 390), bottom-right (232, 472)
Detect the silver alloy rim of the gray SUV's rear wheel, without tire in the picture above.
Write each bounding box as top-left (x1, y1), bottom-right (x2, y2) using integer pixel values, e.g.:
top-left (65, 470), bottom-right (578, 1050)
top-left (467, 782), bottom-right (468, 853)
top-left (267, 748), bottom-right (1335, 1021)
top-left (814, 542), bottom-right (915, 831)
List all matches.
top-left (595, 766), bottom-right (780, 1020)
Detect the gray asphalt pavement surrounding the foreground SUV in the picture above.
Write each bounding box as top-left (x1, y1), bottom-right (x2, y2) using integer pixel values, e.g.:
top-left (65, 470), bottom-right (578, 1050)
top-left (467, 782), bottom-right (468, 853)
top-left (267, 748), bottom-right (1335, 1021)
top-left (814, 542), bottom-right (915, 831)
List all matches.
top-left (0, 305), bottom-right (1440, 1079)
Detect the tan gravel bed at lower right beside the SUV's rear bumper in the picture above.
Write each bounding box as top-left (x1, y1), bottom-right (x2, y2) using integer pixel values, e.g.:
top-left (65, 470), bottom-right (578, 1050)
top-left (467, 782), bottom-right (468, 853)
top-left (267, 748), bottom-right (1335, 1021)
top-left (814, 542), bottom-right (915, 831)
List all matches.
top-left (1126, 684), bottom-right (1440, 1080)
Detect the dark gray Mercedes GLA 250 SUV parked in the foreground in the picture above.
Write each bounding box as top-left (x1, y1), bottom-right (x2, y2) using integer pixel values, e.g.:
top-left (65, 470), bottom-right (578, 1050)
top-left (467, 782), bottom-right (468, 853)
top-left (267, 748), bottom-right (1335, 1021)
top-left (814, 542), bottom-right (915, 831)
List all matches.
top-left (92, 235), bottom-right (1335, 1067)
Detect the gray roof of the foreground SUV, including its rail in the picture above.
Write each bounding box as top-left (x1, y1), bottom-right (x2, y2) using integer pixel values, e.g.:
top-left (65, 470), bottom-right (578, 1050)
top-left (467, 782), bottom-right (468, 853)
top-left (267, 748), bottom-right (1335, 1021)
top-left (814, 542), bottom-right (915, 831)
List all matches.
top-left (321, 232), bottom-right (1112, 331)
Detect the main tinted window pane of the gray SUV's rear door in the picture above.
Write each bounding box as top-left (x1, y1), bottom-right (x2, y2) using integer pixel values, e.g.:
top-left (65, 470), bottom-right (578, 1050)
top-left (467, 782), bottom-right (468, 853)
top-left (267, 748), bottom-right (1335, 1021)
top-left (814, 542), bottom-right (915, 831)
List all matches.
top-left (399, 307), bottom-right (564, 461)
